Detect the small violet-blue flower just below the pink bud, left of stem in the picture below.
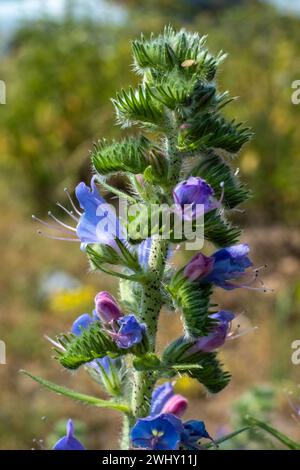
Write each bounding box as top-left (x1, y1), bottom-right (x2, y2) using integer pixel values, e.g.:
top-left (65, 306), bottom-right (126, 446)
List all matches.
top-left (110, 315), bottom-right (146, 349)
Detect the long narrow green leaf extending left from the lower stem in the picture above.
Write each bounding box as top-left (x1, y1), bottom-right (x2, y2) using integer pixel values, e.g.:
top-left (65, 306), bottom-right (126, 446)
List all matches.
top-left (20, 370), bottom-right (130, 413)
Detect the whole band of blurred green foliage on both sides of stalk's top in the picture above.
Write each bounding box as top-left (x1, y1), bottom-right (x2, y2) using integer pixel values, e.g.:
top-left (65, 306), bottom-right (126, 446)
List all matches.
top-left (0, 0), bottom-right (300, 224)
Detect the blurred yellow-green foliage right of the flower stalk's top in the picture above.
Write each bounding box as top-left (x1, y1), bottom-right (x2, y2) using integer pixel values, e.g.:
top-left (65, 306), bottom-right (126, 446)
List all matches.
top-left (197, 5), bottom-right (300, 224)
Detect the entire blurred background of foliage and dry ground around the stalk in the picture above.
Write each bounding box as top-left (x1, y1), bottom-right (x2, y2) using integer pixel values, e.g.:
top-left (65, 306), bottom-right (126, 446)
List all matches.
top-left (0, 0), bottom-right (300, 449)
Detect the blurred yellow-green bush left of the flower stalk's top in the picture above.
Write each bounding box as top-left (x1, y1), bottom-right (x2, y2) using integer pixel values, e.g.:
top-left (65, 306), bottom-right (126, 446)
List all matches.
top-left (0, 15), bottom-right (130, 207)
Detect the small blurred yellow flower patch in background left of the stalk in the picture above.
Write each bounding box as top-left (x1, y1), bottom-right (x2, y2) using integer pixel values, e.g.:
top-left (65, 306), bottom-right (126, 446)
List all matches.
top-left (49, 286), bottom-right (95, 313)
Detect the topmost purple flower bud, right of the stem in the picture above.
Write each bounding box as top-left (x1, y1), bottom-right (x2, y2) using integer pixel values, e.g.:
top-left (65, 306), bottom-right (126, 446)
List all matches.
top-left (173, 176), bottom-right (220, 218)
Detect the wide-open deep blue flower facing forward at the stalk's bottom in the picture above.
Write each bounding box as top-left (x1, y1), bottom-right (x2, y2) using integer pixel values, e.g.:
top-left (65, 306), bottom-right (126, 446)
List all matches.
top-left (131, 414), bottom-right (183, 450)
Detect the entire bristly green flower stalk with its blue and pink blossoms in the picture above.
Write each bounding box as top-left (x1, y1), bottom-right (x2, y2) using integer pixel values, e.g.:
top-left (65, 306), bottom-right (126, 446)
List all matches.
top-left (27, 27), bottom-right (278, 450)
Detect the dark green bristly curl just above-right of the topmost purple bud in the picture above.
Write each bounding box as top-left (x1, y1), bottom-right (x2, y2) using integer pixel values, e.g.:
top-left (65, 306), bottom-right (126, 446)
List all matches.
top-left (188, 151), bottom-right (250, 209)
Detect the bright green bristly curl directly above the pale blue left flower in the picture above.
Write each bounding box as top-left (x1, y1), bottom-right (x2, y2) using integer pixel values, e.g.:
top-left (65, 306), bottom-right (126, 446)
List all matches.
top-left (91, 136), bottom-right (150, 175)
